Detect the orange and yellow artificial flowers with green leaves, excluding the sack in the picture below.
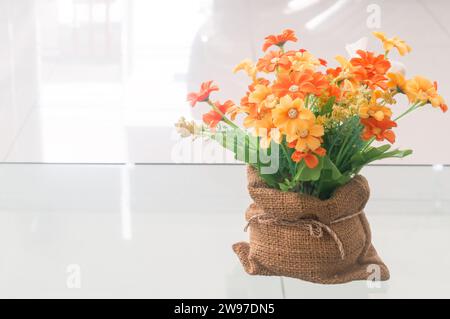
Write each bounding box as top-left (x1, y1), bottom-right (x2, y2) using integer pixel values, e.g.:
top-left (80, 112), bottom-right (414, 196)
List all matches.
top-left (176, 29), bottom-right (447, 199)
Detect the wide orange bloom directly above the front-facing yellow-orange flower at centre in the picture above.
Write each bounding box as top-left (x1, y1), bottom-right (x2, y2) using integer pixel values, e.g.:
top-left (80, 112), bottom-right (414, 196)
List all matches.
top-left (272, 70), bottom-right (328, 99)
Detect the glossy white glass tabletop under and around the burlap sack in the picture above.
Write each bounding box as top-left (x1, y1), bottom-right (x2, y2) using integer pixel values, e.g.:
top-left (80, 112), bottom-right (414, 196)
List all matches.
top-left (0, 164), bottom-right (450, 298)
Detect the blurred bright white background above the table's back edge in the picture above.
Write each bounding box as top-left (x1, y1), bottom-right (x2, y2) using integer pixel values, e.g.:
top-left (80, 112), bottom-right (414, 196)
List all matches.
top-left (0, 0), bottom-right (450, 164)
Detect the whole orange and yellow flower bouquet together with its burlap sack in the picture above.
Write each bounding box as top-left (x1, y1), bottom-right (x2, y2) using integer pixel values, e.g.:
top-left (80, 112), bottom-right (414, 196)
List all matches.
top-left (176, 30), bottom-right (447, 283)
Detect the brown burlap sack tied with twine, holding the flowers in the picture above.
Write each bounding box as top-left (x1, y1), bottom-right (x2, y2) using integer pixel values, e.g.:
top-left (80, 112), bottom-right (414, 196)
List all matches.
top-left (233, 167), bottom-right (389, 284)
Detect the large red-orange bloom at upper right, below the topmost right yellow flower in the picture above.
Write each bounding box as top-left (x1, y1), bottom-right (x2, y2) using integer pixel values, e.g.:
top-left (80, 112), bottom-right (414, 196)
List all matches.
top-left (350, 50), bottom-right (391, 90)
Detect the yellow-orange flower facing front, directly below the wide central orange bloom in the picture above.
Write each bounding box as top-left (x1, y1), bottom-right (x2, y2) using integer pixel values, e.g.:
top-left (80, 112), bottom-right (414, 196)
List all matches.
top-left (272, 95), bottom-right (315, 135)
